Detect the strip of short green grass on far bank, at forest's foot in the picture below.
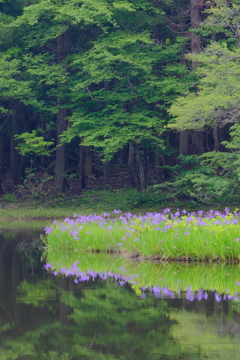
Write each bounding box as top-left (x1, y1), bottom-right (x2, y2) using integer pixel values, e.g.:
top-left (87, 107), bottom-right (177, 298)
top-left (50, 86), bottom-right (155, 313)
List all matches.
top-left (0, 189), bottom-right (223, 221)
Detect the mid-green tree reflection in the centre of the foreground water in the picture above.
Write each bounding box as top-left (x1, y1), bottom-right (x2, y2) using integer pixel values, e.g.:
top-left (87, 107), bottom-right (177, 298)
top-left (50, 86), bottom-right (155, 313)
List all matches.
top-left (63, 282), bottom-right (175, 359)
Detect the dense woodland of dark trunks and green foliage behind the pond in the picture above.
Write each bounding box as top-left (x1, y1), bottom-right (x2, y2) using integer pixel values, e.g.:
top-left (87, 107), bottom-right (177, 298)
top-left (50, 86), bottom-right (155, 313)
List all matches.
top-left (0, 0), bottom-right (240, 205)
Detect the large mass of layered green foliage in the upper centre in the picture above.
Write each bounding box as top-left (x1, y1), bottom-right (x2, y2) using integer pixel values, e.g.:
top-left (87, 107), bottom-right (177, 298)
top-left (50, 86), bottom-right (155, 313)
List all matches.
top-left (62, 34), bottom-right (190, 160)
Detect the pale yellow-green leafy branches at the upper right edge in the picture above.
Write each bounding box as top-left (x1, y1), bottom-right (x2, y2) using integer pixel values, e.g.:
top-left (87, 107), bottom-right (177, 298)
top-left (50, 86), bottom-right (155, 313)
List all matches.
top-left (170, 43), bottom-right (240, 130)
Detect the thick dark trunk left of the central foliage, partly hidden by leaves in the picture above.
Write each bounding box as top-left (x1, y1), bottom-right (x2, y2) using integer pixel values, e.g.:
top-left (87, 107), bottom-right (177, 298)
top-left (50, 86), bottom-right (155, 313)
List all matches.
top-left (53, 32), bottom-right (69, 194)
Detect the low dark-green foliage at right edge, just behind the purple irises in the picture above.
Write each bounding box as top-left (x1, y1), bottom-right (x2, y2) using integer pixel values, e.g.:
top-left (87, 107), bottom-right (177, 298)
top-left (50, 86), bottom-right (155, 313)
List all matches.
top-left (148, 151), bottom-right (240, 205)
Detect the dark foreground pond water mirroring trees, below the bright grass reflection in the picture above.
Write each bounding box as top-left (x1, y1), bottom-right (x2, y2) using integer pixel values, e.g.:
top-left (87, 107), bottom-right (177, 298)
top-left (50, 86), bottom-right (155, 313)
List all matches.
top-left (0, 231), bottom-right (240, 360)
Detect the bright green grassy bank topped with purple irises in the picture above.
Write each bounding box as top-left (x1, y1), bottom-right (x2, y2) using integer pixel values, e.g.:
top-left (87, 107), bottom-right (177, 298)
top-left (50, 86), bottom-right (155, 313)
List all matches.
top-left (45, 208), bottom-right (240, 262)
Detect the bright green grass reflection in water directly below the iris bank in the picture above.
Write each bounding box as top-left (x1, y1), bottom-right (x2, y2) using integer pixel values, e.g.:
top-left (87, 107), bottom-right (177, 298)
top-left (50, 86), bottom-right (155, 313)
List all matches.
top-left (45, 250), bottom-right (240, 296)
